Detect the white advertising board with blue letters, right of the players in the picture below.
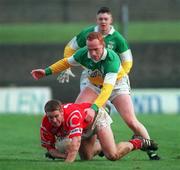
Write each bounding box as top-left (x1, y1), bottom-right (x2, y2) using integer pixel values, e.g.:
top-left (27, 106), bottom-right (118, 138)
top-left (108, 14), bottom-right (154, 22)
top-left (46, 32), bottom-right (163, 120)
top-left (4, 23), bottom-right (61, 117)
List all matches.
top-left (132, 89), bottom-right (180, 114)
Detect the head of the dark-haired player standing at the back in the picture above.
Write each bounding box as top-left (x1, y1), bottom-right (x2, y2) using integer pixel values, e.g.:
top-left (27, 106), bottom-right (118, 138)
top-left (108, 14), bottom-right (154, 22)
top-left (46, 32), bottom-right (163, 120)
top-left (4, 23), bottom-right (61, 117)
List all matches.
top-left (96, 7), bottom-right (113, 34)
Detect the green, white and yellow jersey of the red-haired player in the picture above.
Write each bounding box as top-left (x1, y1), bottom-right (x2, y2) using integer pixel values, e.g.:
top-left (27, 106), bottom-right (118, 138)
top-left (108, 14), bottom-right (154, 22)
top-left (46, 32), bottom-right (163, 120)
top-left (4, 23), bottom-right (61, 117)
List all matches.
top-left (45, 46), bottom-right (122, 109)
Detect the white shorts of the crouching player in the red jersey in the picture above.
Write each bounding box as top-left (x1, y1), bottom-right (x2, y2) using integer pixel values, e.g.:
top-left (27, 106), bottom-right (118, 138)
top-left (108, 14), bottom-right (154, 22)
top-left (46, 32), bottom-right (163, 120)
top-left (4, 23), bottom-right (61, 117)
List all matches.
top-left (82, 108), bottom-right (113, 139)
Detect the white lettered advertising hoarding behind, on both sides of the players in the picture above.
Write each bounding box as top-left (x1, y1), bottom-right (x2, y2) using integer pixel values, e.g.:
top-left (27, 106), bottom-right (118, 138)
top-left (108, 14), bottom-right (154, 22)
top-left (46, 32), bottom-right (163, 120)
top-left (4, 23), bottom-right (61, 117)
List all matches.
top-left (0, 87), bottom-right (180, 114)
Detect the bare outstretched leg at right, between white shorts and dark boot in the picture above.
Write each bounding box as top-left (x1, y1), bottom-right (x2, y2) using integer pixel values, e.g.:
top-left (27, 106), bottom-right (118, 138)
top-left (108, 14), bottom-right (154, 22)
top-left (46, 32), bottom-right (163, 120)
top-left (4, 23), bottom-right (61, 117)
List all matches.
top-left (112, 94), bottom-right (150, 139)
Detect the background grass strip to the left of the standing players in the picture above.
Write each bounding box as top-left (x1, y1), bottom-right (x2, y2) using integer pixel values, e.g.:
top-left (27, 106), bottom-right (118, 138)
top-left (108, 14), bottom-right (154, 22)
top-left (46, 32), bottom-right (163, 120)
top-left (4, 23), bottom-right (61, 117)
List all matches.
top-left (0, 24), bottom-right (87, 44)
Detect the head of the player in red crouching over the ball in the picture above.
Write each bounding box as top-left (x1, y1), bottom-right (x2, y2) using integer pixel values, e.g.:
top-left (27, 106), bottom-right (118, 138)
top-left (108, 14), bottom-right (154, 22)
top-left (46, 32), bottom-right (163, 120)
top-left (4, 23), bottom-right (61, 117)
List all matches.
top-left (44, 100), bottom-right (64, 127)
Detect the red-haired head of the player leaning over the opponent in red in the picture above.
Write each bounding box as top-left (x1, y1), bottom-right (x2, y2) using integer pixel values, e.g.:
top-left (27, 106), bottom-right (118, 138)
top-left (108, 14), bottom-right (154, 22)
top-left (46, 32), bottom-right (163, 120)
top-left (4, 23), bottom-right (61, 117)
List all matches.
top-left (86, 32), bottom-right (105, 61)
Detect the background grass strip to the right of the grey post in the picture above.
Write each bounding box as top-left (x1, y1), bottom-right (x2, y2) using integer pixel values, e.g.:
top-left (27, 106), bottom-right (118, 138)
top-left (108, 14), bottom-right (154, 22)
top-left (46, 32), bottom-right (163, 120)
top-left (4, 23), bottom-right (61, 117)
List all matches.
top-left (128, 22), bottom-right (180, 42)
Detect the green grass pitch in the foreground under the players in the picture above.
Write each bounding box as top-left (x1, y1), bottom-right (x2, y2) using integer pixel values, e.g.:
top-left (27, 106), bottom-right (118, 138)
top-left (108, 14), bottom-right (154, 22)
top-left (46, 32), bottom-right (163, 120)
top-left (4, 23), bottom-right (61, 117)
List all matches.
top-left (0, 114), bottom-right (180, 170)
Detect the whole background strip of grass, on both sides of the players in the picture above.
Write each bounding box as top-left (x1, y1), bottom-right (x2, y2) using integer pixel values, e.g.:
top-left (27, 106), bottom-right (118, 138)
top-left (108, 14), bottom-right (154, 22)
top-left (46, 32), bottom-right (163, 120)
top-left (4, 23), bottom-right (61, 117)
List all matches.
top-left (0, 21), bottom-right (180, 44)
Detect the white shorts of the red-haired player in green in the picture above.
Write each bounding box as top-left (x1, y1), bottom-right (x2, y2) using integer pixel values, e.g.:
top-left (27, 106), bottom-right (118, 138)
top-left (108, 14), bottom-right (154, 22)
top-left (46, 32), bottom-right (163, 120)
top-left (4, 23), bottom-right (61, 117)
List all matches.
top-left (80, 70), bottom-right (131, 101)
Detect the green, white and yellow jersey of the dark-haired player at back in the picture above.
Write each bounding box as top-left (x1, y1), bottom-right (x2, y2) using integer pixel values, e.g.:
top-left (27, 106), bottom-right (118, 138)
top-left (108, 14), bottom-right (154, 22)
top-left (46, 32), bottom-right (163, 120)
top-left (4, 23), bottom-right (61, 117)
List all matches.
top-left (64, 25), bottom-right (133, 74)
